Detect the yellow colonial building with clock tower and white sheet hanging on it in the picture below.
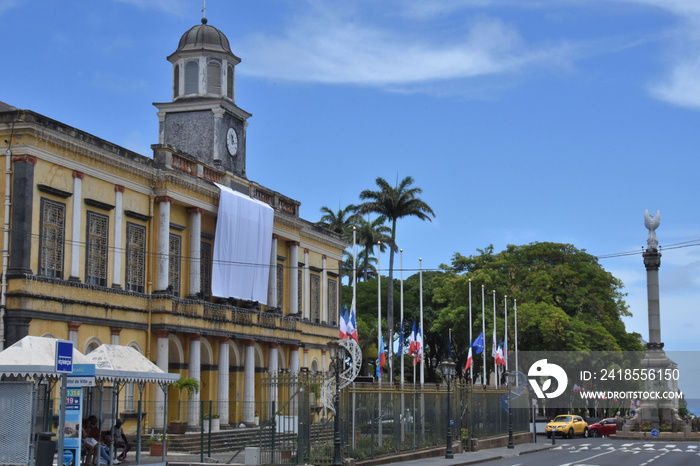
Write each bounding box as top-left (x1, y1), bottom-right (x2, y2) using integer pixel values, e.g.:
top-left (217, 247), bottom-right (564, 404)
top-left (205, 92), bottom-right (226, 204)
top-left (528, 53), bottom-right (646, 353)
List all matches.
top-left (0, 19), bottom-right (346, 427)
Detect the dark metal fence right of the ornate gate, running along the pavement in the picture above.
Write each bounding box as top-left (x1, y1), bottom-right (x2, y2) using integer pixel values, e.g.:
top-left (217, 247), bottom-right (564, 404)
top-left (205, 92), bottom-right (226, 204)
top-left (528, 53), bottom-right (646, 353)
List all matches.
top-left (341, 384), bottom-right (529, 459)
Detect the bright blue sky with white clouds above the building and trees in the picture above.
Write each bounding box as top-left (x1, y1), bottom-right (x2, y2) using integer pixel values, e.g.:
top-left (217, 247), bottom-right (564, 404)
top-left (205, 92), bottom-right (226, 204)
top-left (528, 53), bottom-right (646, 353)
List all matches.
top-left (0, 0), bottom-right (700, 351)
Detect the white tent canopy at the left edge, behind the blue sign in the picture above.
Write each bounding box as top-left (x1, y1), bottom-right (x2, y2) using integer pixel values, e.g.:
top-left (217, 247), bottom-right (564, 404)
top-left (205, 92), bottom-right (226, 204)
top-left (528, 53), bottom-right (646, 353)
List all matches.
top-left (0, 336), bottom-right (93, 377)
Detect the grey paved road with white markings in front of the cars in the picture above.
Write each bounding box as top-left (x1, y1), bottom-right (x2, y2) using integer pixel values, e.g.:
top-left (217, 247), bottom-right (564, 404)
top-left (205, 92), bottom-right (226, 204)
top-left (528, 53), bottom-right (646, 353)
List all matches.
top-left (482, 438), bottom-right (700, 466)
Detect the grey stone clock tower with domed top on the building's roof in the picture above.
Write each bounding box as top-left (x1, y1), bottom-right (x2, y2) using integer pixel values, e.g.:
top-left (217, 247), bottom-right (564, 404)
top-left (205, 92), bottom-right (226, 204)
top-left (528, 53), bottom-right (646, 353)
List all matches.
top-left (153, 18), bottom-right (252, 178)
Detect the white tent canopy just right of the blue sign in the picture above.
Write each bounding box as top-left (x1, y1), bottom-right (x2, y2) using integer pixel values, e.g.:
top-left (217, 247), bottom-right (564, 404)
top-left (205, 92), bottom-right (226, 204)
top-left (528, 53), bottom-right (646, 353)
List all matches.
top-left (85, 345), bottom-right (180, 383)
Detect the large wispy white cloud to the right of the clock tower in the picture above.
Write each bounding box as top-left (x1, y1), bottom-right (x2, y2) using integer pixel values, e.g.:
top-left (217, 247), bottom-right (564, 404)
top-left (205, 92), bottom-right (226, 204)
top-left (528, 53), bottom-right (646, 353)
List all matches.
top-left (244, 8), bottom-right (561, 90)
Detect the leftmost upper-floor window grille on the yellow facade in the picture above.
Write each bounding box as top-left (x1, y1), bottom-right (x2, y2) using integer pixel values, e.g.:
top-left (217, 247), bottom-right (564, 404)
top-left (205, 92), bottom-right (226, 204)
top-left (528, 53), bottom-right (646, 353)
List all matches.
top-left (39, 198), bottom-right (66, 278)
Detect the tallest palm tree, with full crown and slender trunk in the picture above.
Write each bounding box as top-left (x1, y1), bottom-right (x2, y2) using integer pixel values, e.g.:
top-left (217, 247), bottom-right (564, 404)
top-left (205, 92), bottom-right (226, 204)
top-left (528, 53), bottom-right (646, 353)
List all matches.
top-left (360, 176), bottom-right (435, 380)
